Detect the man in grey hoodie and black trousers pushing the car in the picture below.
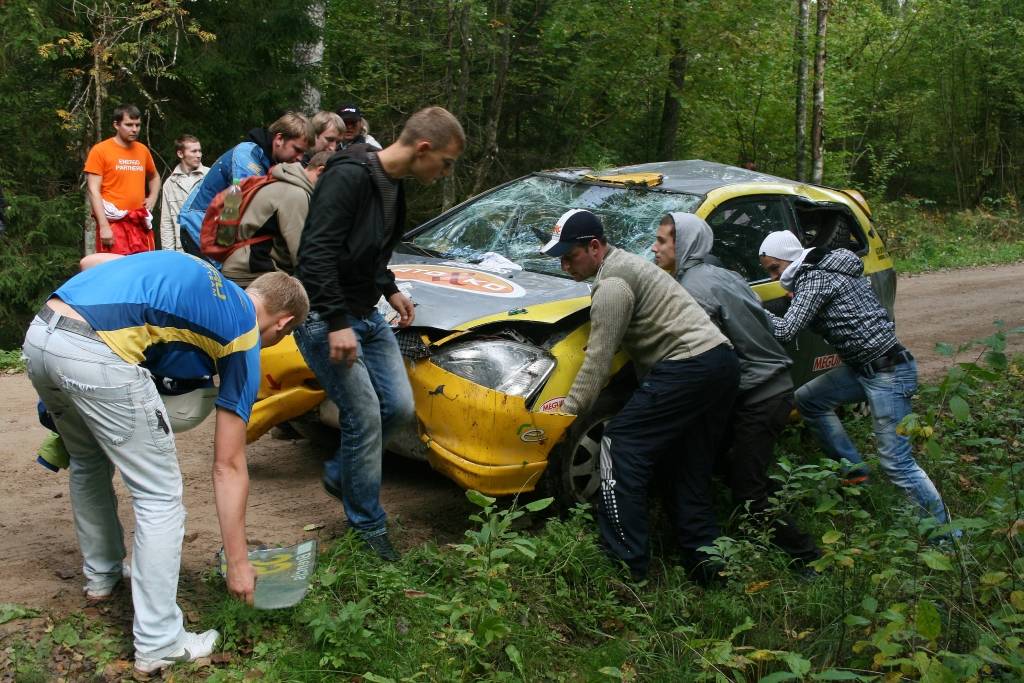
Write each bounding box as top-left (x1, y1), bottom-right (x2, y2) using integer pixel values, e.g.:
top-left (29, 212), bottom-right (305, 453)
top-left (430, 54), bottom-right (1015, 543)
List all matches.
top-left (651, 213), bottom-right (820, 562)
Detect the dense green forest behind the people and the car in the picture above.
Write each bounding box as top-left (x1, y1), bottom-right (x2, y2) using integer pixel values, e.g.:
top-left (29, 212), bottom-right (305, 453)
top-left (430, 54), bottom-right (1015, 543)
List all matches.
top-left (0, 0), bottom-right (1024, 348)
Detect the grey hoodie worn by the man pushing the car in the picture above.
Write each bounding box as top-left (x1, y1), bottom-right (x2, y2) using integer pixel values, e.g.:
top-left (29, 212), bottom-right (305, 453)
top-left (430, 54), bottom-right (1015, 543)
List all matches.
top-left (670, 212), bottom-right (793, 402)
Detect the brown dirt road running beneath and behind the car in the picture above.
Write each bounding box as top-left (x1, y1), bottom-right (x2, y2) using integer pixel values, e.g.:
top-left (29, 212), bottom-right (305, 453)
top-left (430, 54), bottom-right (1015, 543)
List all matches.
top-left (0, 264), bottom-right (1024, 611)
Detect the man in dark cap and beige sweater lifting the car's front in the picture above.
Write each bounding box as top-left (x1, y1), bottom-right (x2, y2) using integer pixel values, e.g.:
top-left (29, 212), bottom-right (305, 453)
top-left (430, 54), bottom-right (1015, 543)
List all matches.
top-left (541, 209), bottom-right (739, 583)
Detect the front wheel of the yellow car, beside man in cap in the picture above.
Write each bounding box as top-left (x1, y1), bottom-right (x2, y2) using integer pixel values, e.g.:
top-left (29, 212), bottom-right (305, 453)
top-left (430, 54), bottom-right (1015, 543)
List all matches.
top-left (542, 394), bottom-right (625, 514)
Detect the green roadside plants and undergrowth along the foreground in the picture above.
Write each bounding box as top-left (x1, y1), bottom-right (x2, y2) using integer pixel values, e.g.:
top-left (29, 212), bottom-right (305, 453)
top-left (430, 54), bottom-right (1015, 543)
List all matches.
top-left (0, 329), bottom-right (1024, 683)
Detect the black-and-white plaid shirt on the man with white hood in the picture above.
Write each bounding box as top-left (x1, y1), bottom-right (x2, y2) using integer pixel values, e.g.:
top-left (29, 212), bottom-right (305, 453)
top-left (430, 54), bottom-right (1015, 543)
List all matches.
top-left (768, 249), bottom-right (898, 367)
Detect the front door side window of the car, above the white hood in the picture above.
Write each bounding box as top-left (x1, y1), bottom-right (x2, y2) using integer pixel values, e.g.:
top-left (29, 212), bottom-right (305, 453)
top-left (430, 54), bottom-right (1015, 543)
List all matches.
top-left (708, 197), bottom-right (790, 282)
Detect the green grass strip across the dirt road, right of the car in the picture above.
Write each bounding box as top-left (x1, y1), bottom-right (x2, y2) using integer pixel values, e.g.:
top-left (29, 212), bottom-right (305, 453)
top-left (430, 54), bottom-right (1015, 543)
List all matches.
top-left (874, 201), bottom-right (1024, 273)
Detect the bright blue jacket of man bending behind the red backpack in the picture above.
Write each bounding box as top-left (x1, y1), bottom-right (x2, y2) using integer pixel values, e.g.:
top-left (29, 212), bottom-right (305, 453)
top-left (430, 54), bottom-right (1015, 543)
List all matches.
top-left (178, 128), bottom-right (273, 255)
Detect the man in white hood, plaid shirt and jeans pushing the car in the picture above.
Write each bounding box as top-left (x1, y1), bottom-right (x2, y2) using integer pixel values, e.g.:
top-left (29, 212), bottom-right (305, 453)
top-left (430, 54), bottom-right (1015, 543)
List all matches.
top-left (758, 230), bottom-right (949, 523)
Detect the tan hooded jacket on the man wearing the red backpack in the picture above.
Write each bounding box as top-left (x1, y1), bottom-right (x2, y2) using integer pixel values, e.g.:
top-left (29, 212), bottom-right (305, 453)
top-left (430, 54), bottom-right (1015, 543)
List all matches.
top-left (222, 162), bottom-right (313, 287)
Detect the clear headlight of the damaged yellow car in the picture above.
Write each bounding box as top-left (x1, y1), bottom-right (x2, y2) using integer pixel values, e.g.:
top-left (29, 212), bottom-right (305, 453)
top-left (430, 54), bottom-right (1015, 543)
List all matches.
top-left (431, 339), bottom-right (555, 402)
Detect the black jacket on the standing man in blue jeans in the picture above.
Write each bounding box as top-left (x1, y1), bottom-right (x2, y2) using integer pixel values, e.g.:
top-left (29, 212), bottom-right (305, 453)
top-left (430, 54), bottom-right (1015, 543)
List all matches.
top-left (296, 153), bottom-right (406, 332)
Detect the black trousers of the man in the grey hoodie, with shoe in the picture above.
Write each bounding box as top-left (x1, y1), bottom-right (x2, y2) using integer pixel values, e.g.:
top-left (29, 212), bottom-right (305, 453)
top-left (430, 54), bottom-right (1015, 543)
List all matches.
top-left (717, 391), bottom-right (820, 561)
